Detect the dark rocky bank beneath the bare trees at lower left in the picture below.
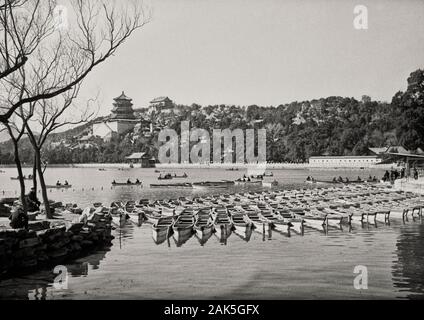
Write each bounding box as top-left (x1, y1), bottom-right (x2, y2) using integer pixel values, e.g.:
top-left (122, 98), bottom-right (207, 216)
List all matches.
top-left (0, 213), bottom-right (114, 279)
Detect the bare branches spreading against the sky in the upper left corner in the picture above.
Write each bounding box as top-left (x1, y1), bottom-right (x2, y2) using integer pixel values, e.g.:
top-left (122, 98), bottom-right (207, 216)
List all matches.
top-left (0, 0), bottom-right (149, 123)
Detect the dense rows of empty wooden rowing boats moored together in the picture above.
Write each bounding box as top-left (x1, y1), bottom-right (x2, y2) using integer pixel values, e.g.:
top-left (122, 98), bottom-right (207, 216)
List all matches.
top-left (88, 185), bottom-right (424, 245)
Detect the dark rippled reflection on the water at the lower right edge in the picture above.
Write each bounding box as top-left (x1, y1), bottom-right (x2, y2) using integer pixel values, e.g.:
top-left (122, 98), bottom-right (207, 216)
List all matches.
top-left (392, 223), bottom-right (424, 299)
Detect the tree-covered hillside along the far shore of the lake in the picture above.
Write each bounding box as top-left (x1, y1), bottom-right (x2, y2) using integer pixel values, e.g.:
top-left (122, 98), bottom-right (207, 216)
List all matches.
top-left (0, 69), bottom-right (424, 164)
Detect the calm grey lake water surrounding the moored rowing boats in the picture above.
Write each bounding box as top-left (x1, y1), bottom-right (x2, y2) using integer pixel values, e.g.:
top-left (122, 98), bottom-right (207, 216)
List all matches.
top-left (0, 168), bottom-right (424, 299)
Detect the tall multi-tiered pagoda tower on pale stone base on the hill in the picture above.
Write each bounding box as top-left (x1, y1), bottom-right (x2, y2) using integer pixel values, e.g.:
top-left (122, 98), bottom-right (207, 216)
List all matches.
top-left (92, 92), bottom-right (140, 141)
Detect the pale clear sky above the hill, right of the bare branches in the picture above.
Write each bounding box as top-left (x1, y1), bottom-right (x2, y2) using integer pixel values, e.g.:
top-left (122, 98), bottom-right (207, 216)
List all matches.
top-left (77, 0), bottom-right (424, 114)
